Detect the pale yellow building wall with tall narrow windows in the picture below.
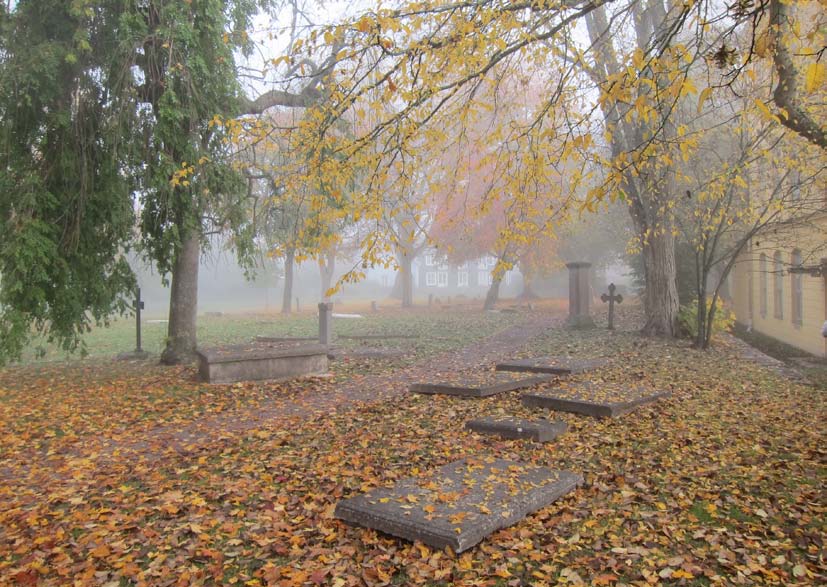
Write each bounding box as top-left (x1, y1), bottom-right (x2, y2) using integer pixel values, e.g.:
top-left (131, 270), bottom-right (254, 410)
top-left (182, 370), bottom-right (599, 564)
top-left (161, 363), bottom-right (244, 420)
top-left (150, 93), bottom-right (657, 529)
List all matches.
top-left (732, 216), bottom-right (827, 358)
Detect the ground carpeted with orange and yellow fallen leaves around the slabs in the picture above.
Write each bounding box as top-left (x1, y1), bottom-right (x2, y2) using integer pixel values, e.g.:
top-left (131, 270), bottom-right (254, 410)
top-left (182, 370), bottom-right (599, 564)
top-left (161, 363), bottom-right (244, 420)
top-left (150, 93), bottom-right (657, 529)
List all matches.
top-left (0, 312), bottom-right (827, 586)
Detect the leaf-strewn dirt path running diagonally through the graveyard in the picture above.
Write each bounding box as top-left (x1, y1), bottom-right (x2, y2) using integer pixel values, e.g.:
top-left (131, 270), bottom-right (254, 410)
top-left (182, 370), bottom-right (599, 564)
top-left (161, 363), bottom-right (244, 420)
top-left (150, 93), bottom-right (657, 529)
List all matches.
top-left (0, 314), bottom-right (561, 480)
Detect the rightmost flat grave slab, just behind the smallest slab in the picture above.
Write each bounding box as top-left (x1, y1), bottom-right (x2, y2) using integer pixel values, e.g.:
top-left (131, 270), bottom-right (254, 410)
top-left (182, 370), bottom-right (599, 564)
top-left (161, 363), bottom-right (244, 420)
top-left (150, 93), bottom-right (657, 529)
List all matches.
top-left (522, 382), bottom-right (672, 418)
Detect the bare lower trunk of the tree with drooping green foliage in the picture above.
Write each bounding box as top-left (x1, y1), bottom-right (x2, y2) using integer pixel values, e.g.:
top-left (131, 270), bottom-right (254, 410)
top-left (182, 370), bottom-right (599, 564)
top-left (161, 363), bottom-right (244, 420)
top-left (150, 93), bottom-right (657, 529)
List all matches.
top-left (161, 231), bottom-right (201, 365)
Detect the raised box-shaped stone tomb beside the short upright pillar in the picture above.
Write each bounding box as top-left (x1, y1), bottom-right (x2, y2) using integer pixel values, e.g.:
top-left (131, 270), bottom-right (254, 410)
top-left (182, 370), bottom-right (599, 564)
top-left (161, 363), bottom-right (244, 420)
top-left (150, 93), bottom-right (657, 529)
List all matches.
top-left (197, 341), bottom-right (327, 383)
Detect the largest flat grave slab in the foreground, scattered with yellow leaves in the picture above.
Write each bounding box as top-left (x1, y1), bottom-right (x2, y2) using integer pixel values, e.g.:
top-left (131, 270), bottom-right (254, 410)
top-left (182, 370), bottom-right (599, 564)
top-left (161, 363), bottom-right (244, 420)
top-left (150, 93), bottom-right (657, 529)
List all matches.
top-left (334, 457), bottom-right (583, 553)
